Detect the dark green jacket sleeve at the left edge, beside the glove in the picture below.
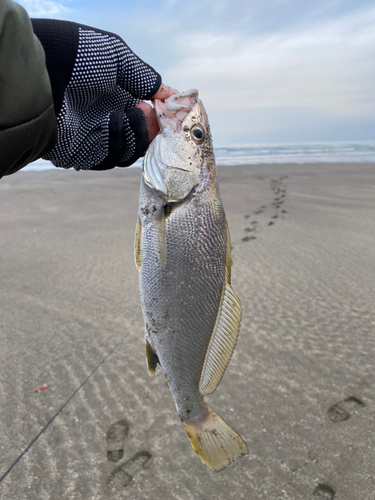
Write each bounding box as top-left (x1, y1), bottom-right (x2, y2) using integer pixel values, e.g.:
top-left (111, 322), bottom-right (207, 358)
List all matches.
top-left (0, 0), bottom-right (57, 178)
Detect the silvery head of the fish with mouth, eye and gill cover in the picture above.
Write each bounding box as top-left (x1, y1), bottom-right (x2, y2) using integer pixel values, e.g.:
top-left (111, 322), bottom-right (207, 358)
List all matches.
top-left (143, 89), bottom-right (213, 202)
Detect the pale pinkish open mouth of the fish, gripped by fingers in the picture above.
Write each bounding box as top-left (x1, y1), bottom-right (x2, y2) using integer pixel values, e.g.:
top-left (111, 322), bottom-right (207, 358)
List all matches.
top-left (153, 89), bottom-right (198, 132)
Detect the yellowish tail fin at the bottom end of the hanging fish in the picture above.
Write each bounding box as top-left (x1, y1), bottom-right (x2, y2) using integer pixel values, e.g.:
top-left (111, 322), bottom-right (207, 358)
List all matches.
top-left (183, 406), bottom-right (248, 472)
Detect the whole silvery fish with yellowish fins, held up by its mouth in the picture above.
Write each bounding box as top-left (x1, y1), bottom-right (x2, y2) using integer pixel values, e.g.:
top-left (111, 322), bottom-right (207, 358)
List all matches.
top-left (135, 89), bottom-right (248, 471)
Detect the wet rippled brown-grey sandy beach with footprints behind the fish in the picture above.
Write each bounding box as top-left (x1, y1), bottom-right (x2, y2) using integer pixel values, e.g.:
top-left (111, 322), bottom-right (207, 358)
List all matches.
top-left (0, 163), bottom-right (375, 500)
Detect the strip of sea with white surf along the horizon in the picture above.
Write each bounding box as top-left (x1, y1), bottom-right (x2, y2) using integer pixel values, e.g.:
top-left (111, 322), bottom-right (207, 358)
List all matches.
top-left (22, 141), bottom-right (375, 171)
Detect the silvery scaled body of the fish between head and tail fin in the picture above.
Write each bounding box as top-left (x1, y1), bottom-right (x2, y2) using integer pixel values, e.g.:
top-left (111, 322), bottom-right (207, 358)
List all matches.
top-left (139, 180), bottom-right (226, 417)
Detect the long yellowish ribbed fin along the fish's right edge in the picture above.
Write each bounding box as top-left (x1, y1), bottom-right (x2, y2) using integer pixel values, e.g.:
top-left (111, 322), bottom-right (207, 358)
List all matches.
top-left (199, 222), bottom-right (241, 394)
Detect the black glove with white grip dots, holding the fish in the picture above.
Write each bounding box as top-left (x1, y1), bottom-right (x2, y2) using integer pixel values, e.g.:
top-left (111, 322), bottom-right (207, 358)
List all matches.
top-left (31, 19), bottom-right (161, 170)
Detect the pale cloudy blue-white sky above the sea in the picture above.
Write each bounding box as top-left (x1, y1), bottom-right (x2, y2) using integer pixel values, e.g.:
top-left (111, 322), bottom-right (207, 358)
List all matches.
top-left (19, 0), bottom-right (375, 145)
